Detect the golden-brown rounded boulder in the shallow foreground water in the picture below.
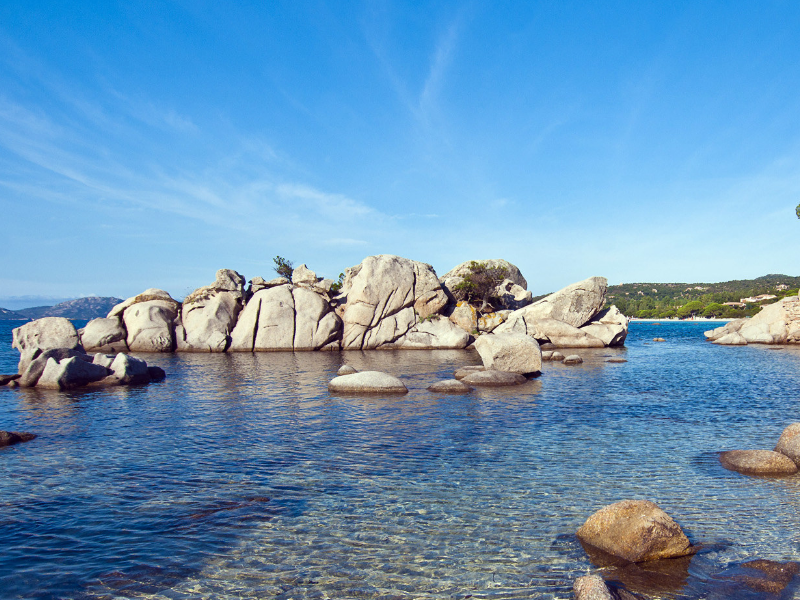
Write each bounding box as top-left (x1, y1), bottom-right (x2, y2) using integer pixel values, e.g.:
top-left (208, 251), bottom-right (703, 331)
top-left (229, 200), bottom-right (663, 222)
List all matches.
top-left (577, 500), bottom-right (696, 562)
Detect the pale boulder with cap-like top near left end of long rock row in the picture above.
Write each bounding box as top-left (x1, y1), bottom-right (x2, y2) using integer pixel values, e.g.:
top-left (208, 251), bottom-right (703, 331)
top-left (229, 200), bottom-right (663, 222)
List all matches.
top-left (108, 288), bottom-right (180, 352)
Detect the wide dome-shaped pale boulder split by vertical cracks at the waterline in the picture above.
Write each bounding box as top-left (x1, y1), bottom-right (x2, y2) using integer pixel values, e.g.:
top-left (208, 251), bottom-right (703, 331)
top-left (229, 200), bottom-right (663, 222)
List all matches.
top-left (230, 284), bottom-right (341, 352)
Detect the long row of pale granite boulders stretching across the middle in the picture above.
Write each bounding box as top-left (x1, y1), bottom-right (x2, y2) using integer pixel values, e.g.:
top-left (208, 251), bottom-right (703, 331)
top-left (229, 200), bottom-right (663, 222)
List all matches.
top-left (36, 254), bottom-right (628, 352)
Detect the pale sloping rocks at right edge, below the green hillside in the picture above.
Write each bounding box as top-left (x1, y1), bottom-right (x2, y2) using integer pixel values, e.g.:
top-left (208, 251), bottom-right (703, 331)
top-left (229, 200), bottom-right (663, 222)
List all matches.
top-left (705, 296), bottom-right (800, 346)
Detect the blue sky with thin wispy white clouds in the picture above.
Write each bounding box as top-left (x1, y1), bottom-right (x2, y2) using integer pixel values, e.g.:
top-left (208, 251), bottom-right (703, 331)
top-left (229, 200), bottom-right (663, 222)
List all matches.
top-left (0, 0), bottom-right (800, 306)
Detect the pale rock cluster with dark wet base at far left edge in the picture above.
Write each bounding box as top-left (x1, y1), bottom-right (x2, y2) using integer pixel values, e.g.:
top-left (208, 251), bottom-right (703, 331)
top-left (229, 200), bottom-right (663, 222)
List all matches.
top-left (0, 317), bottom-right (164, 390)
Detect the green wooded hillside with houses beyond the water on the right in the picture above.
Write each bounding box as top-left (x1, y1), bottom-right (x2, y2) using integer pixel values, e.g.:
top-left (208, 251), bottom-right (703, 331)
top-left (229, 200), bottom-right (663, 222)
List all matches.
top-left (607, 275), bottom-right (800, 319)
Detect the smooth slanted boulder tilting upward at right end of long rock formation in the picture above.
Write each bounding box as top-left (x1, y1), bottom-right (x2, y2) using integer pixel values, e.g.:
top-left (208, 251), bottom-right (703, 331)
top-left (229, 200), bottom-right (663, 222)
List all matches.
top-left (507, 277), bottom-right (608, 327)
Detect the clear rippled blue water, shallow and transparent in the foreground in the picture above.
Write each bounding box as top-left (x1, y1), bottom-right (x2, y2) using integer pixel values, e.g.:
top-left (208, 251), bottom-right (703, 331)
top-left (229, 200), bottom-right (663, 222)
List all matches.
top-left (0, 322), bottom-right (800, 599)
